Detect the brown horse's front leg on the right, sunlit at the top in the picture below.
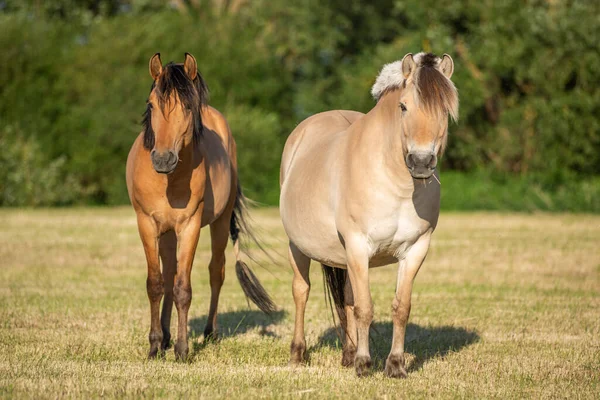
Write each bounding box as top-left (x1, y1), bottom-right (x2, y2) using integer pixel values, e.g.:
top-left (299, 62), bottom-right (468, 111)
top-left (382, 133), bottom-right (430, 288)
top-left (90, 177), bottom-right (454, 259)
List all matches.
top-left (173, 214), bottom-right (202, 361)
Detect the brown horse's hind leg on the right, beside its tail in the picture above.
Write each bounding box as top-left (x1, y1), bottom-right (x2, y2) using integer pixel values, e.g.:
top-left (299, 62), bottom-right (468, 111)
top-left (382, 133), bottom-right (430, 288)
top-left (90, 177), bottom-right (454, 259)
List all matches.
top-left (204, 209), bottom-right (231, 340)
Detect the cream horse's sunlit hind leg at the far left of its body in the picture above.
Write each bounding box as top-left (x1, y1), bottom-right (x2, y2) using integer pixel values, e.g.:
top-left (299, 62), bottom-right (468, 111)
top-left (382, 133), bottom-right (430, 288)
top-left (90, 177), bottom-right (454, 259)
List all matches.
top-left (289, 242), bottom-right (310, 365)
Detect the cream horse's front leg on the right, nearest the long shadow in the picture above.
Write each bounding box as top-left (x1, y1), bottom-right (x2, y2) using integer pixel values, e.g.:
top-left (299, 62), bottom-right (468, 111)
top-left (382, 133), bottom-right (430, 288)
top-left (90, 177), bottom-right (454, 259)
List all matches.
top-left (385, 232), bottom-right (431, 378)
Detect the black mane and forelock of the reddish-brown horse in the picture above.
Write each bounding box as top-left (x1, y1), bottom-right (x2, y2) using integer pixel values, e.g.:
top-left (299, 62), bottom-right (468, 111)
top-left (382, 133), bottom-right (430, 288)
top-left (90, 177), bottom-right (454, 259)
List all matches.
top-left (142, 62), bottom-right (208, 150)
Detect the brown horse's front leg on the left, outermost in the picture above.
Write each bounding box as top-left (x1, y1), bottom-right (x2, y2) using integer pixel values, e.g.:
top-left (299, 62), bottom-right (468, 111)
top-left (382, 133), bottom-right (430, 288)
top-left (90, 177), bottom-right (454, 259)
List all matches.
top-left (137, 212), bottom-right (164, 358)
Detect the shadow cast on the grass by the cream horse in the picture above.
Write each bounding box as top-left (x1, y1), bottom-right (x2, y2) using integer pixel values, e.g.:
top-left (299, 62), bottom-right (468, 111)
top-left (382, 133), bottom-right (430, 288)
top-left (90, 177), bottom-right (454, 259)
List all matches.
top-left (308, 321), bottom-right (479, 372)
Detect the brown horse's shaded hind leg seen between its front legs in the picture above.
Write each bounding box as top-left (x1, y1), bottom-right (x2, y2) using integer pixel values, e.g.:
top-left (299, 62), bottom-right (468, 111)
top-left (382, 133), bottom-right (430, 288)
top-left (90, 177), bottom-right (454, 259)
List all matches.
top-left (159, 231), bottom-right (177, 351)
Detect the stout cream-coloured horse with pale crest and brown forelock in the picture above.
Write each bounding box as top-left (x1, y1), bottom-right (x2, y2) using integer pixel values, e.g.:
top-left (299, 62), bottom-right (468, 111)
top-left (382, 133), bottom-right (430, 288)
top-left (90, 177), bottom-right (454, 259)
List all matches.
top-left (280, 53), bottom-right (458, 377)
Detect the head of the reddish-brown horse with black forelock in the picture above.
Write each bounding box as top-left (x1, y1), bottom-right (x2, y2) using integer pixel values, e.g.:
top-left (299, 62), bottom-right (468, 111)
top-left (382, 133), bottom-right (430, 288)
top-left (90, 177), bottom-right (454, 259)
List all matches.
top-left (142, 53), bottom-right (208, 174)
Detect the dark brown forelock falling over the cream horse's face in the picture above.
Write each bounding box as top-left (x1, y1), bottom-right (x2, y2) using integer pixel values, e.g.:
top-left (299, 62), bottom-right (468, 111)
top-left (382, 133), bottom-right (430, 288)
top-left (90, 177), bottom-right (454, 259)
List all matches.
top-left (414, 53), bottom-right (458, 120)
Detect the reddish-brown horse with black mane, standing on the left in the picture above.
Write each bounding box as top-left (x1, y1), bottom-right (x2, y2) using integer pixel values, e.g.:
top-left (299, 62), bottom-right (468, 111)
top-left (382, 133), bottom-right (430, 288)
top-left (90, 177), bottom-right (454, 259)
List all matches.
top-left (126, 53), bottom-right (274, 360)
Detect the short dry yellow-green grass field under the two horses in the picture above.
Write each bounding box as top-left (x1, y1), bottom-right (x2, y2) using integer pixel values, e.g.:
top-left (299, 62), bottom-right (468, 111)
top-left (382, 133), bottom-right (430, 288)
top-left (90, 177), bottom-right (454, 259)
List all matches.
top-left (0, 208), bottom-right (600, 399)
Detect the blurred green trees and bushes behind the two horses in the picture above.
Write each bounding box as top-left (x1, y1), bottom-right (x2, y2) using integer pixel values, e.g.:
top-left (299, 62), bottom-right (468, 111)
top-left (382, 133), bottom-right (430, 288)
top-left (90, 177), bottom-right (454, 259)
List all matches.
top-left (0, 0), bottom-right (600, 211)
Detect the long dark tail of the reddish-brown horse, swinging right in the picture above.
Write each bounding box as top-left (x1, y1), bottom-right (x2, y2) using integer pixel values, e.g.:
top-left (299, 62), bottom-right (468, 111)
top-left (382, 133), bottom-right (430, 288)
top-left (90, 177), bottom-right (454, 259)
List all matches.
top-left (229, 182), bottom-right (276, 314)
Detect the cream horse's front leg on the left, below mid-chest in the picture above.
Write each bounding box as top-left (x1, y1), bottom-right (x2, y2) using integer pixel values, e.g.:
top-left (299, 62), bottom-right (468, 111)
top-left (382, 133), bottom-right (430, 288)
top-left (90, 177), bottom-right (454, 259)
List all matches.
top-left (344, 237), bottom-right (373, 376)
